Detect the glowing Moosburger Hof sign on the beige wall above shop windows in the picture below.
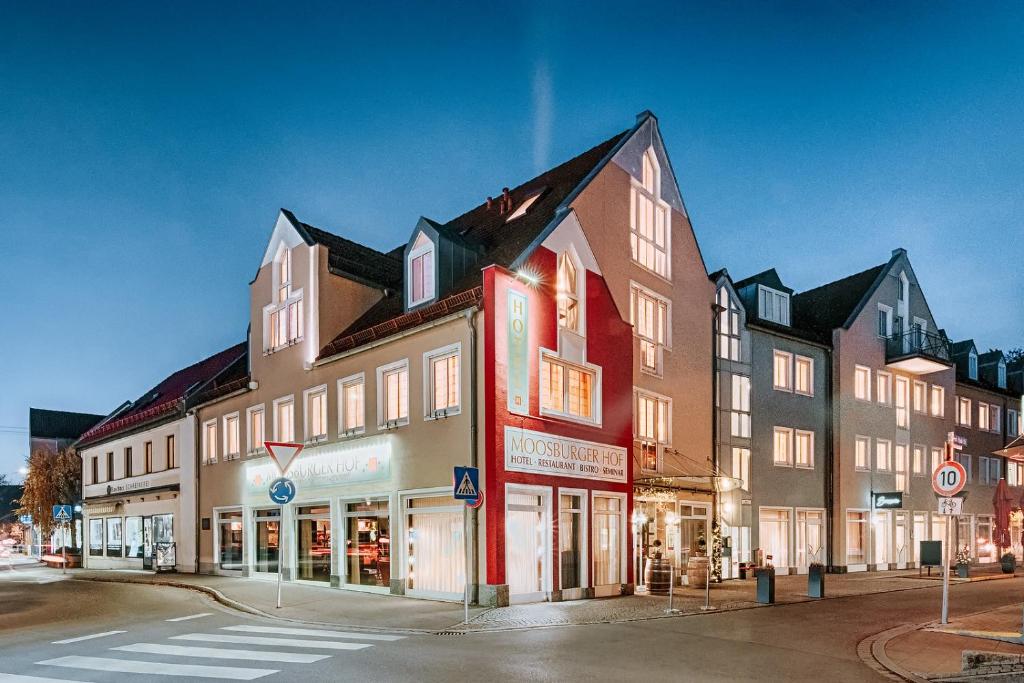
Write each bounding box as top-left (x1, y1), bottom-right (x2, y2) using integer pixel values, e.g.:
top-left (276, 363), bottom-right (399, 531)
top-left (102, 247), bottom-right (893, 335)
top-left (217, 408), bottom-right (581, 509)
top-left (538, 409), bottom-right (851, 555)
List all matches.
top-left (246, 437), bottom-right (391, 496)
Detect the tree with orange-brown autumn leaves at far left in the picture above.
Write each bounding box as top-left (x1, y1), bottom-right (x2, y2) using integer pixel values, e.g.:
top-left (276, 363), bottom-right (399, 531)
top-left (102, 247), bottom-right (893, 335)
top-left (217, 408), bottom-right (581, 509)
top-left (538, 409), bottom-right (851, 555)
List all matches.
top-left (18, 449), bottom-right (82, 539)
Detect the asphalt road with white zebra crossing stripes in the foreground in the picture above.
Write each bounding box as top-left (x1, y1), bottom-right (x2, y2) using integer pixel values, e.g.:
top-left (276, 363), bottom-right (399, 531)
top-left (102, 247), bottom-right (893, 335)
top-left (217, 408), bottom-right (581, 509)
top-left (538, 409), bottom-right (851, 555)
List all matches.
top-left (0, 569), bottom-right (1024, 683)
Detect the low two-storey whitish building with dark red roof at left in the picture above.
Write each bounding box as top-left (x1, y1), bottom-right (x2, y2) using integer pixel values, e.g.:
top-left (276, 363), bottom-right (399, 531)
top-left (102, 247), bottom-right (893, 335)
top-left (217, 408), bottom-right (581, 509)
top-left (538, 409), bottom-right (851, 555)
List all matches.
top-left (75, 344), bottom-right (246, 571)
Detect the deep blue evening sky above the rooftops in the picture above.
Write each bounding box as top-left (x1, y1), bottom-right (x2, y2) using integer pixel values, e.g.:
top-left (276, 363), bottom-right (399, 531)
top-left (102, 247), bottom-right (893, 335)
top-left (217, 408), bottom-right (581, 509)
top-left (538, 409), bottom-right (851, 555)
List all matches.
top-left (0, 0), bottom-right (1024, 478)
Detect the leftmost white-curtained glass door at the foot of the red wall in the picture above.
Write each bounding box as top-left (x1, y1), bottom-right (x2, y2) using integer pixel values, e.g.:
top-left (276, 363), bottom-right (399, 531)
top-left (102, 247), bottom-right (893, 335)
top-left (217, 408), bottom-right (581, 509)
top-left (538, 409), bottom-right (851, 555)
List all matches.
top-left (505, 489), bottom-right (549, 602)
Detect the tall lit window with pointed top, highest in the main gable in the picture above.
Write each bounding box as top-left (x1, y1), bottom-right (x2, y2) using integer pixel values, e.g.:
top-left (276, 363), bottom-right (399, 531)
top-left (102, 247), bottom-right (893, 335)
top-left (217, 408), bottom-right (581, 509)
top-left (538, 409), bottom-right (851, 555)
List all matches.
top-left (630, 150), bottom-right (672, 279)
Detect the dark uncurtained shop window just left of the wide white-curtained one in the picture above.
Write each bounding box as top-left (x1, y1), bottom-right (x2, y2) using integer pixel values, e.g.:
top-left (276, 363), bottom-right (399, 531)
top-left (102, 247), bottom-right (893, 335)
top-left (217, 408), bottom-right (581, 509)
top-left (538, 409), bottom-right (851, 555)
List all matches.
top-left (345, 500), bottom-right (391, 588)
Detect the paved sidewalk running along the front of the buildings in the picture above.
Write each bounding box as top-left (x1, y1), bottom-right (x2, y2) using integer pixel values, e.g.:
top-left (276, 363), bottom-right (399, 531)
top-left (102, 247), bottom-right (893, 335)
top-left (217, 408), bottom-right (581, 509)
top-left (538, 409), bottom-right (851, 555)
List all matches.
top-left (69, 565), bottom-right (1012, 632)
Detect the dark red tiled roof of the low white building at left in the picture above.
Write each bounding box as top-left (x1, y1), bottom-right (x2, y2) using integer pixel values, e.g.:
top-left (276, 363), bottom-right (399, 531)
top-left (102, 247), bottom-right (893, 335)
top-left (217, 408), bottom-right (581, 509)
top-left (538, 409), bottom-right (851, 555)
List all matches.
top-left (77, 342), bottom-right (249, 446)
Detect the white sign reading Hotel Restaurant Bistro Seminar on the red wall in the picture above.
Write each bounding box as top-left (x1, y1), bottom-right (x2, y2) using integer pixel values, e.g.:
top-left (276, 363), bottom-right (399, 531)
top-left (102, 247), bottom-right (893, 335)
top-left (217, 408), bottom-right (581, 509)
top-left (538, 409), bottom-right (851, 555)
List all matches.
top-left (505, 426), bottom-right (629, 483)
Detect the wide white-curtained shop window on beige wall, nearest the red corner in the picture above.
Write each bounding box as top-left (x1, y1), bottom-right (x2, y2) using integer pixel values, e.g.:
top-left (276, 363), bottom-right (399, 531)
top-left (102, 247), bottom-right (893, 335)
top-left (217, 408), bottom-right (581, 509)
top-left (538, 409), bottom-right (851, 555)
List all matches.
top-left (406, 497), bottom-right (466, 596)
